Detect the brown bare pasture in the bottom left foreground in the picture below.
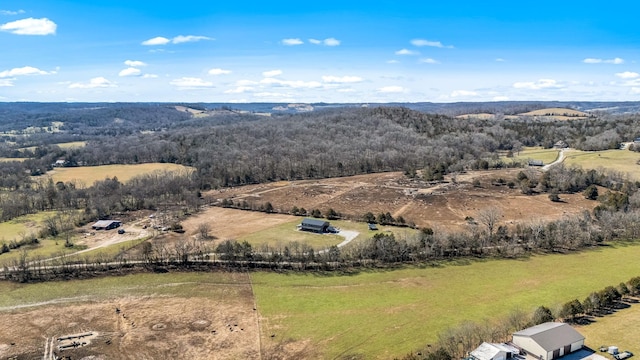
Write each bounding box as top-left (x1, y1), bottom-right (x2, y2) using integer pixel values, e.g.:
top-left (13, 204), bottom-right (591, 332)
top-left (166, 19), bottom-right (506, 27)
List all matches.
top-left (0, 285), bottom-right (260, 360)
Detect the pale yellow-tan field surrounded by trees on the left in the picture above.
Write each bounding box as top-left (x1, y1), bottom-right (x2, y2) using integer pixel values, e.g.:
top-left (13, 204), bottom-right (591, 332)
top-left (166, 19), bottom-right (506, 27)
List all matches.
top-left (46, 163), bottom-right (192, 186)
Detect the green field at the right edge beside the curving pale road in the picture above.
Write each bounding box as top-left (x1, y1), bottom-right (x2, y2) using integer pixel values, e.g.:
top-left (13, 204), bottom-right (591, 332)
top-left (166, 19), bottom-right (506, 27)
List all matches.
top-left (564, 150), bottom-right (640, 180)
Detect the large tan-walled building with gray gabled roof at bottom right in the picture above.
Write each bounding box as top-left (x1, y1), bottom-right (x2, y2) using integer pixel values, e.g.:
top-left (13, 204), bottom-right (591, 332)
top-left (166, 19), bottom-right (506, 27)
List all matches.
top-left (513, 322), bottom-right (584, 360)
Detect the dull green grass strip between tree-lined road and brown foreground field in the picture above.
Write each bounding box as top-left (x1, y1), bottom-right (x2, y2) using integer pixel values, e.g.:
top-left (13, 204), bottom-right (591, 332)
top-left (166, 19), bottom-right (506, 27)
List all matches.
top-left (0, 272), bottom-right (248, 310)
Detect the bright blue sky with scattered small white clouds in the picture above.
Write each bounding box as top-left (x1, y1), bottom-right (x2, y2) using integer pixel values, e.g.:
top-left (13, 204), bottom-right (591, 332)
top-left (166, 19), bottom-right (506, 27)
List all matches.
top-left (0, 0), bottom-right (640, 103)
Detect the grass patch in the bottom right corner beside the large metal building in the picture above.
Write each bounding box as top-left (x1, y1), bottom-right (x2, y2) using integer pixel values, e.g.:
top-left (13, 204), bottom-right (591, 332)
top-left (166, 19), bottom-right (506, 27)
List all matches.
top-left (578, 298), bottom-right (640, 355)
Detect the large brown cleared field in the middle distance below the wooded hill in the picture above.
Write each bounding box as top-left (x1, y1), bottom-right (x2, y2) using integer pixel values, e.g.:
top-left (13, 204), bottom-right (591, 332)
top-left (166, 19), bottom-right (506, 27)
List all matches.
top-left (208, 169), bottom-right (597, 229)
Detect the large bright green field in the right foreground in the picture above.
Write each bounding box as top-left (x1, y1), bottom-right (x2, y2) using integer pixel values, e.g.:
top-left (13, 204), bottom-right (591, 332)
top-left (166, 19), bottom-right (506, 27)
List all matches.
top-left (252, 244), bottom-right (640, 359)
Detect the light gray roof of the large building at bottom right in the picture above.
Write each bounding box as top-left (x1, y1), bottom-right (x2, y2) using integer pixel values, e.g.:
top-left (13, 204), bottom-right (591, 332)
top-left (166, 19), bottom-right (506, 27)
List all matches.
top-left (513, 322), bottom-right (584, 351)
